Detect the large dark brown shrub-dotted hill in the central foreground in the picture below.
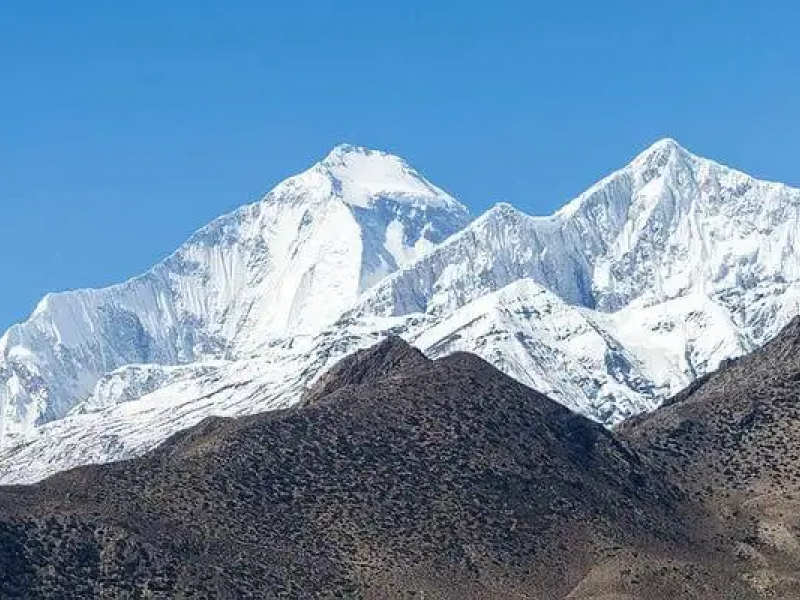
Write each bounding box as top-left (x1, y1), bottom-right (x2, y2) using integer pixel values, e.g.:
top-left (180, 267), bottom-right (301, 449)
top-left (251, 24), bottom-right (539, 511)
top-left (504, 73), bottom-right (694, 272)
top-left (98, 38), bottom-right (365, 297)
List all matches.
top-left (0, 338), bottom-right (754, 600)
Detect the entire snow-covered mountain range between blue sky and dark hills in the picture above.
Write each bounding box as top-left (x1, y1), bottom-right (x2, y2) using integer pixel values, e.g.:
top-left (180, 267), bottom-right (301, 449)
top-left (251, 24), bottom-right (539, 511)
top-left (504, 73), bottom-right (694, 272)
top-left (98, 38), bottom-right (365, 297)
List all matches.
top-left (0, 139), bottom-right (800, 481)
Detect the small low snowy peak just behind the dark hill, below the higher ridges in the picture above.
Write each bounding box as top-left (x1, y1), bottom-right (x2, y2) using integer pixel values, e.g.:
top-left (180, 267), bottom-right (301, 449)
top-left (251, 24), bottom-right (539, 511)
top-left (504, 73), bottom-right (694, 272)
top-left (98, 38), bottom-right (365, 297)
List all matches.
top-left (412, 279), bottom-right (663, 423)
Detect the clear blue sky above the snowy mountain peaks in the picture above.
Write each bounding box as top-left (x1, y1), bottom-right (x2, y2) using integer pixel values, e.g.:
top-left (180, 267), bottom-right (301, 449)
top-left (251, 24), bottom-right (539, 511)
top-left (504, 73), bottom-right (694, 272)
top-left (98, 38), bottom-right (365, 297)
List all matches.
top-left (0, 0), bottom-right (800, 330)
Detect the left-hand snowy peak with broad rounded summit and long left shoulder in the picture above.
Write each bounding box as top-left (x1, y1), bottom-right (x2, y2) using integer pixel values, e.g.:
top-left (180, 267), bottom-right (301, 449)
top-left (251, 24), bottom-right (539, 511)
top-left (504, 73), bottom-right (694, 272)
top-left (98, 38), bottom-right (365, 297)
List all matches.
top-left (0, 146), bottom-right (469, 443)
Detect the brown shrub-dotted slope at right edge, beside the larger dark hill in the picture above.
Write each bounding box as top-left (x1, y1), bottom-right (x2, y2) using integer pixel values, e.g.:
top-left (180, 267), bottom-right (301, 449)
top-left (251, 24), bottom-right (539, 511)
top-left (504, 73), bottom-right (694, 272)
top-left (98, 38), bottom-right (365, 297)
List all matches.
top-left (617, 317), bottom-right (800, 598)
